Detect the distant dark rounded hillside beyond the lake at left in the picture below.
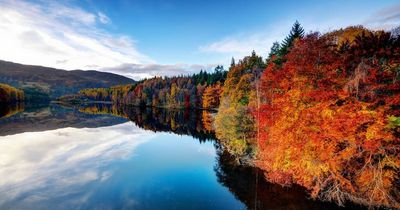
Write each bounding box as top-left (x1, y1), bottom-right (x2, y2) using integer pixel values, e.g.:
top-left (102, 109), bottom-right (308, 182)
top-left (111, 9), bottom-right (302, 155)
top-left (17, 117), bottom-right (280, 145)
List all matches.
top-left (0, 60), bottom-right (135, 99)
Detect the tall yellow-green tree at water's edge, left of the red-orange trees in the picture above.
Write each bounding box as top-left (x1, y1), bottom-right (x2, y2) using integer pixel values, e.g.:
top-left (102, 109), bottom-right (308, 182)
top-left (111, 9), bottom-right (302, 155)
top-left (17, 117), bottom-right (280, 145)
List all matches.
top-left (215, 51), bottom-right (266, 158)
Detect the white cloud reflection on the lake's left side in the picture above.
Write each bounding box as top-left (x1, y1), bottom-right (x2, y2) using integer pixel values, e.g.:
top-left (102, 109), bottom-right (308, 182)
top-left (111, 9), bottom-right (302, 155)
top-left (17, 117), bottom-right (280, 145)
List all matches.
top-left (0, 122), bottom-right (156, 208)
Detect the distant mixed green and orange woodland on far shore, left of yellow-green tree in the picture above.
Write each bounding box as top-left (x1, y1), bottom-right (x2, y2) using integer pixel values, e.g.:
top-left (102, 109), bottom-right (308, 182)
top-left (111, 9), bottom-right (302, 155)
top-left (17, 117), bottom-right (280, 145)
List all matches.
top-left (79, 66), bottom-right (227, 109)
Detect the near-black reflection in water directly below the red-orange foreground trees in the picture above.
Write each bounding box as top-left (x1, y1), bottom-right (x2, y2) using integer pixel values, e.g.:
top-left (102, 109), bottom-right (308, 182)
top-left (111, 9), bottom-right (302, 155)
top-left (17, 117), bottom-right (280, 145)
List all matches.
top-left (214, 150), bottom-right (366, 210)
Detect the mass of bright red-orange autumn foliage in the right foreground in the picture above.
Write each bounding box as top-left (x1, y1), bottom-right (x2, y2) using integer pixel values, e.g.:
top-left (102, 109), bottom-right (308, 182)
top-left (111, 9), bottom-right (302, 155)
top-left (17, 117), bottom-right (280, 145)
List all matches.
top-left (255, 29), bottom-right (400, 207)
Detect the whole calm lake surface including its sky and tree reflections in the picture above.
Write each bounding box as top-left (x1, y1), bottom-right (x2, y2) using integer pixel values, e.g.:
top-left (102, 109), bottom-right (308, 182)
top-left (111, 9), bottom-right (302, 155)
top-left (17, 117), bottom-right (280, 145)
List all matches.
top-left (0, 104), bottom-right (368, 210)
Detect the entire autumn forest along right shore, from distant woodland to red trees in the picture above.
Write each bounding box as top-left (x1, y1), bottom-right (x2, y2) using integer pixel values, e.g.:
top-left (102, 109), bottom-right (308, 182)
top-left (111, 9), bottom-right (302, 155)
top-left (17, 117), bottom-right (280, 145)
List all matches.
top-left (57, 22), bottom-right (400, 208)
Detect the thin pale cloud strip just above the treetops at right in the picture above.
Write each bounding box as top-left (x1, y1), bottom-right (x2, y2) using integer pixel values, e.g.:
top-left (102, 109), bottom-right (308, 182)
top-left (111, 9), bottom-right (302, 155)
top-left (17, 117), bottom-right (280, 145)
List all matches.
top-left (199, 4), bottom-right (400, 59)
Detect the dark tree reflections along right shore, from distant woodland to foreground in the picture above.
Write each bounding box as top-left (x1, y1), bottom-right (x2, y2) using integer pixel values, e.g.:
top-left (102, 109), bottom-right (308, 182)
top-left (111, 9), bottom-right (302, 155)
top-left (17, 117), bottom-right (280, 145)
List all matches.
top-left (74, 104), bottom-right (366, 210)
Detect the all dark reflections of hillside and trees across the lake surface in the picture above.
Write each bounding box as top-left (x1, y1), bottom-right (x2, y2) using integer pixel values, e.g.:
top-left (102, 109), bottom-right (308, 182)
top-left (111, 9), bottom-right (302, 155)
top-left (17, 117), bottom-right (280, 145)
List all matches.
top-left (0, 104), bottom-right (372, 209)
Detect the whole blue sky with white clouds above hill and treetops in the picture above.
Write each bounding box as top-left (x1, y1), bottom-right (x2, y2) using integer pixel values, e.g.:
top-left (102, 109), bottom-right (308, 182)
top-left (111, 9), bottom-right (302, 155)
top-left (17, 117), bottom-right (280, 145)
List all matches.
top-left (0, 0), bottom-right (400, 80)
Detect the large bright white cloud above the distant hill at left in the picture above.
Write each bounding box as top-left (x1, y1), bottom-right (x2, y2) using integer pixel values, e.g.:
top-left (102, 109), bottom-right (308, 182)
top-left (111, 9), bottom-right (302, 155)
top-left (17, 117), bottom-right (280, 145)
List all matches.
top-left (0, 0), bottom-right (153, 69)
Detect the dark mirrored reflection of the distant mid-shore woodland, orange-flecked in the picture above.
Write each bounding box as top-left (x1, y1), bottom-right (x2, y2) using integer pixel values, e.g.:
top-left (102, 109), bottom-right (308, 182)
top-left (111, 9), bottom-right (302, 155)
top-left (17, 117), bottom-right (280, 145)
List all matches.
top-left (77, 103), bottom-right (216, 142)
